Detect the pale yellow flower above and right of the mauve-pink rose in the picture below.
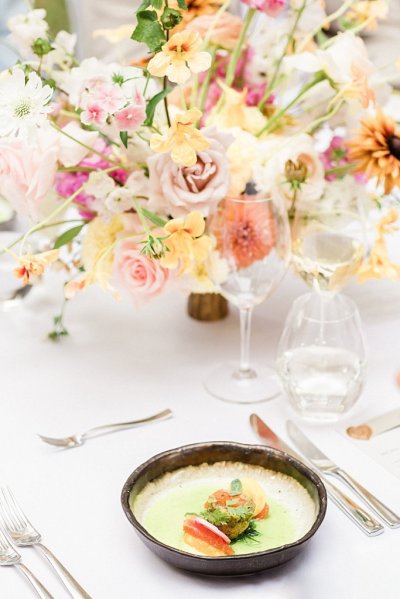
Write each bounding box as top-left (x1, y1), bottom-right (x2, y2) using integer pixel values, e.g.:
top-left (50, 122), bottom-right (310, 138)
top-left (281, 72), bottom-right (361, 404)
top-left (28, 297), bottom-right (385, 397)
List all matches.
top-left (207, 81), bottom-right (266, 133)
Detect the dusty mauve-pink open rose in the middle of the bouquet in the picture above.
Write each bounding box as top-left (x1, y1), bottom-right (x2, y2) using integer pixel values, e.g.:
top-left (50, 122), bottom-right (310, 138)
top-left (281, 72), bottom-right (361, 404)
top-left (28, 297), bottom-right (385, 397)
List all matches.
top-left (147, 127), bottom-right (233, 218)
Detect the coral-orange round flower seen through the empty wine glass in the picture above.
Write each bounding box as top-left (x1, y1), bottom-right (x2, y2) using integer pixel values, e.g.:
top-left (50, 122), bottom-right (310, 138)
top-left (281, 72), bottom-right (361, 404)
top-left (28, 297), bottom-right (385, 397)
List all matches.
top-left (214, 198), bottom-right (276, 268)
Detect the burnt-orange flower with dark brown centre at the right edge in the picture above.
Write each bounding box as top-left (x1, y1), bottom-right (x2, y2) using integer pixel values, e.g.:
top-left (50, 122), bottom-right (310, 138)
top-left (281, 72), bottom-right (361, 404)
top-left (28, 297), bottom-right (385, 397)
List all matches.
top-left (348, 110), bottom-right (400, 193)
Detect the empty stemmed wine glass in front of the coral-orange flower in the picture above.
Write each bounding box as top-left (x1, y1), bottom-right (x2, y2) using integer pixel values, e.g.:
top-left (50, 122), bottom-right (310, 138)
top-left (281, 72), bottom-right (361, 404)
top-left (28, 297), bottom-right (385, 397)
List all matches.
top-left (205, 193), bottom-right (290, 403)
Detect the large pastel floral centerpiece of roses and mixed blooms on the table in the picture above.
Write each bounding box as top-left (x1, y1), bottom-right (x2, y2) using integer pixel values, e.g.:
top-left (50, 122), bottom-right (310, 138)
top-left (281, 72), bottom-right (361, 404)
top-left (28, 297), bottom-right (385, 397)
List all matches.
top-left (0, 0), bottom-right (400, 338)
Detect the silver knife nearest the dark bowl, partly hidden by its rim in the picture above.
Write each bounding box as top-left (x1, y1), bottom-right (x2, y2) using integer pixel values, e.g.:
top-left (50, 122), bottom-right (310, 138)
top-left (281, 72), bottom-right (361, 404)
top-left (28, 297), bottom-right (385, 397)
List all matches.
top-left (250, 414), bottom-right (384, 537)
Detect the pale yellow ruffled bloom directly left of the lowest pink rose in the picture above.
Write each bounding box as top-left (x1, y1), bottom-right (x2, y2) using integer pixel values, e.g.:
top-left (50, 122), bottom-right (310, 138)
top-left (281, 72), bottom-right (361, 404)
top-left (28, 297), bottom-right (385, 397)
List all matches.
top-left (80, 215), bottom-right (124, 294)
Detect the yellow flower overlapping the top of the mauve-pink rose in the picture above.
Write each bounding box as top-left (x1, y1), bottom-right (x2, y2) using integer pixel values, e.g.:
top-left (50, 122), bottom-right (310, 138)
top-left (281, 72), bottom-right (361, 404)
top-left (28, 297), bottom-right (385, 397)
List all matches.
top-left (150, 108), bottom-right (210, 166)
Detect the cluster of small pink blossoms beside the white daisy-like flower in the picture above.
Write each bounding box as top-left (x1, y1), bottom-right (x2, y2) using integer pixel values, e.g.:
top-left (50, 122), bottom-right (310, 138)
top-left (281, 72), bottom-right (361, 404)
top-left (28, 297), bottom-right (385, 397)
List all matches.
top-left (55, 139), bottom-right (129, 220)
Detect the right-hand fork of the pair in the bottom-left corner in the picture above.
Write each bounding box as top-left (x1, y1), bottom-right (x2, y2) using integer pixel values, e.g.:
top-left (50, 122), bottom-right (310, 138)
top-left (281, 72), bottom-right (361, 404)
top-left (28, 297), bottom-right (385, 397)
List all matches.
top-left (0, 487), bottom-right (91, 599)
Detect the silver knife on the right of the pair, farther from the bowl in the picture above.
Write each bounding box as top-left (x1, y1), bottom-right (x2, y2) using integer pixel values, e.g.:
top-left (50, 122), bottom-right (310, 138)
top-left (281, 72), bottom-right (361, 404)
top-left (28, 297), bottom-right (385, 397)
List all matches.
top-left (286, 420), bottom-right (400, 528)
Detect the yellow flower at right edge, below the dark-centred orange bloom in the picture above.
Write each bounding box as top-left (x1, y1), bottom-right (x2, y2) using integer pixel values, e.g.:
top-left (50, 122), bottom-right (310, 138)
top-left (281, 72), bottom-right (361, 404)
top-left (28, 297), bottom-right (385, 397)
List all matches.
top-left (357, 208), bottom-right (400, 283)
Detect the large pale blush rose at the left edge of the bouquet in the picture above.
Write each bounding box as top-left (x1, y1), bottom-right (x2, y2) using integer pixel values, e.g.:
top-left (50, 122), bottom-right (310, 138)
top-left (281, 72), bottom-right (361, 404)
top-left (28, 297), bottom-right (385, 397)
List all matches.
top-left (0, 137), bottom-right (59, 221)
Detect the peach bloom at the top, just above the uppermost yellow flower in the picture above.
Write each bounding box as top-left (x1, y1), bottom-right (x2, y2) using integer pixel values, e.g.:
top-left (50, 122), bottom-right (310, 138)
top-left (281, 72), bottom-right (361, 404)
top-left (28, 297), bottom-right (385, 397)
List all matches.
top-left (186, 12), bottom-right (243, 50)
